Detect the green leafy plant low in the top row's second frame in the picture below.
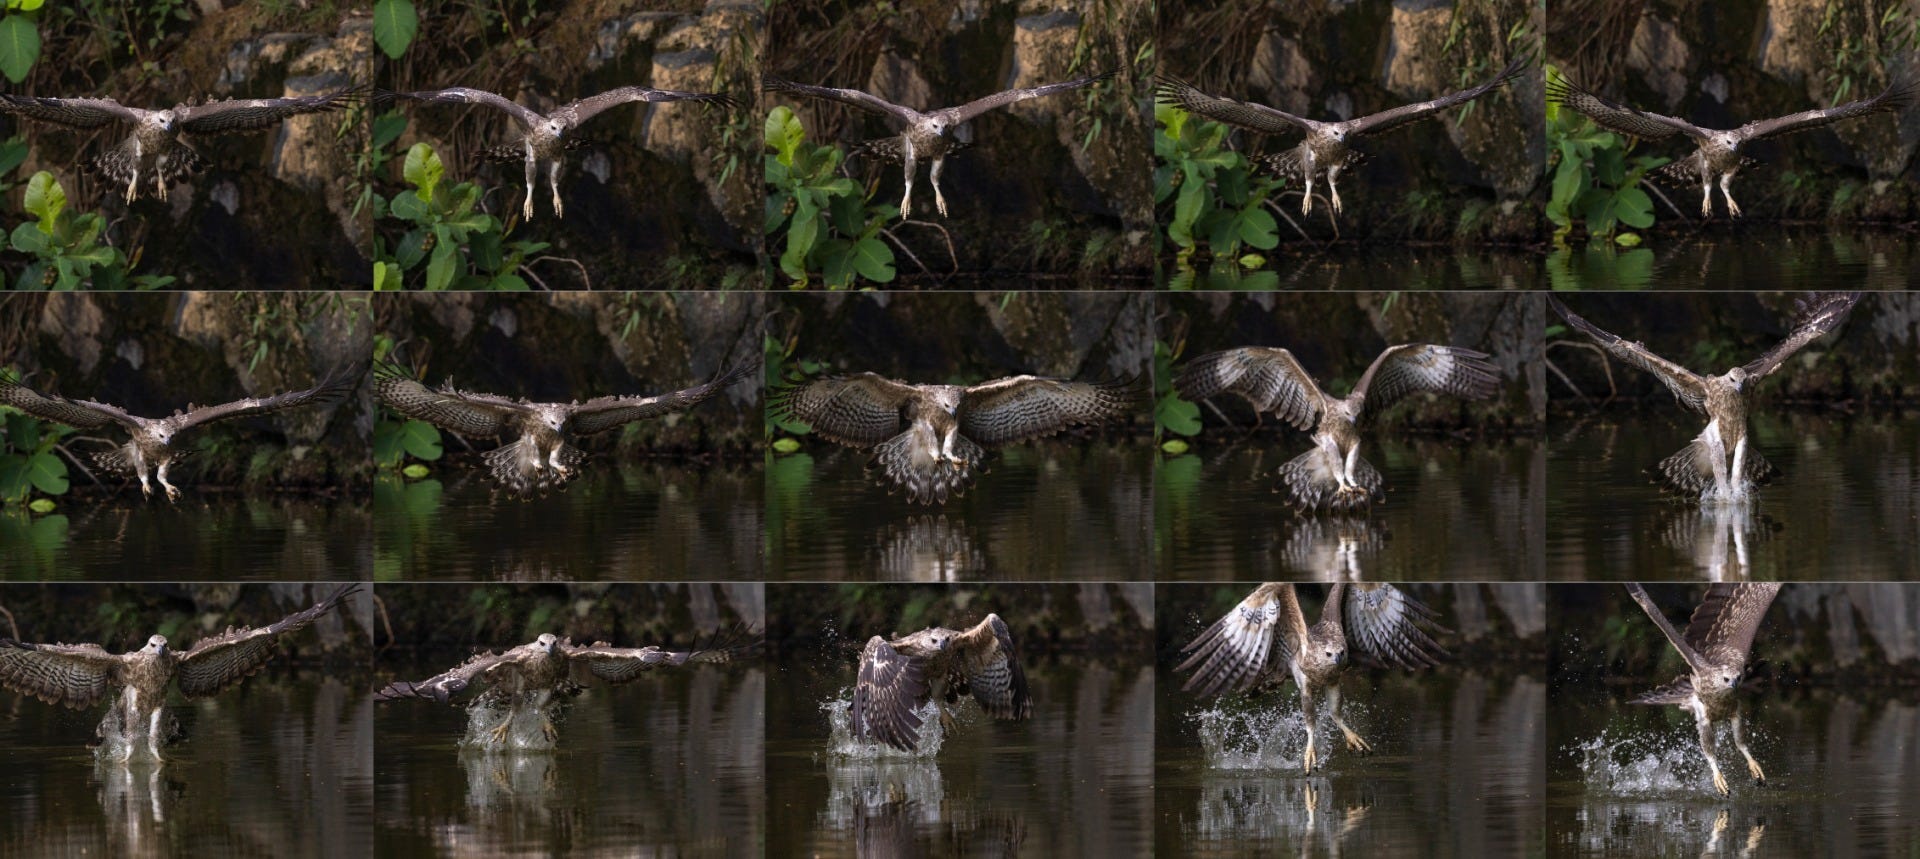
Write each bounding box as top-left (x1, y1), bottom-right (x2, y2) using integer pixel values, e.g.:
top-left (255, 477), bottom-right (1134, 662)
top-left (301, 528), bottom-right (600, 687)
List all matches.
top-left (374, 142), bottom-right (547, 292)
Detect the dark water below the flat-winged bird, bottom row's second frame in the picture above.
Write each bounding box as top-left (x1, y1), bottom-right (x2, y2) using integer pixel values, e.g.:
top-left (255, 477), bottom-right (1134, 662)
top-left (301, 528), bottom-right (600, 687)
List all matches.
top-left (374, 653), bottom-right (766, 857)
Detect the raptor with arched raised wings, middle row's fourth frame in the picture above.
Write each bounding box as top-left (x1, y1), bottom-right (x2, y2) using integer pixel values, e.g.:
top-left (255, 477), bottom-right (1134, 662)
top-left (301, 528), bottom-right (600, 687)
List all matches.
top-left (1173, 344), bottom-right (1500, 511)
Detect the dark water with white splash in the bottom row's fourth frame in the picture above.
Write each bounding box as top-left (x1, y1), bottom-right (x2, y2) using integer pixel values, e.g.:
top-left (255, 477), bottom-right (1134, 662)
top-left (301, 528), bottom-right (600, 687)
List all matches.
top-left (1154, 671), bottom-right (1546, 857)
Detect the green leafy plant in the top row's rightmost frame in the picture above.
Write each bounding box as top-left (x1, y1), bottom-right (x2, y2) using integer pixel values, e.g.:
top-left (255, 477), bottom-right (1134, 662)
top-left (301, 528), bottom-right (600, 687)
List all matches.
top-left (1548, 67), bottom-right (1668, 246)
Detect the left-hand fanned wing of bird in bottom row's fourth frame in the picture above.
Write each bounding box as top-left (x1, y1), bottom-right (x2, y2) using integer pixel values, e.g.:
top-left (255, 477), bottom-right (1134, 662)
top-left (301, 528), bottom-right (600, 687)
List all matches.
top-left (1173, 582), bottom-right (1308, 696)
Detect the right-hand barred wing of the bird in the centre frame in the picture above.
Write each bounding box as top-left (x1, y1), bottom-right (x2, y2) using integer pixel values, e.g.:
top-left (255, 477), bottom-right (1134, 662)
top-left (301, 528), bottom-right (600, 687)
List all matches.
top-left (958, 377), bottom-right (1139, 444)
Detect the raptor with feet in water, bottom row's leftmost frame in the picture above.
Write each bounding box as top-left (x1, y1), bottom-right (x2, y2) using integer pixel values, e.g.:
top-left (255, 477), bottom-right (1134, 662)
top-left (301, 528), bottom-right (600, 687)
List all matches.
top-left (0, 584), bottom-right (359, 761)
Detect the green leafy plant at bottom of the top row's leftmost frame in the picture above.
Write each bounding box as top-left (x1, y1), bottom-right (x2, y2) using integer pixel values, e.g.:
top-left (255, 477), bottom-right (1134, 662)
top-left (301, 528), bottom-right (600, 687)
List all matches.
top-left (8, 171), bottom-right (173, 290)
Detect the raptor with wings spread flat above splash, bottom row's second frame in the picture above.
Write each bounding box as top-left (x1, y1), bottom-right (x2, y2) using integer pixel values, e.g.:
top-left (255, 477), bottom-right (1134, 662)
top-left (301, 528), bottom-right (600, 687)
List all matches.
top-left (372, 626), bottom-right (760, 748)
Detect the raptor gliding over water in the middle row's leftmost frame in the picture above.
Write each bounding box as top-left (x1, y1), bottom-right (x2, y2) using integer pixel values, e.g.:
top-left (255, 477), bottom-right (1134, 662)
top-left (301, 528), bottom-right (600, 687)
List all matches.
top-left (0, 367), bottom-right (361, 502)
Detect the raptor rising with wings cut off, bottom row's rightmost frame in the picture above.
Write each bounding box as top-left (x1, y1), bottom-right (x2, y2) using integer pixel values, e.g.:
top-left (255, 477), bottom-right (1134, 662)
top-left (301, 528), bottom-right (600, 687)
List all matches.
top-left (1626, 582), bottom-right (1780, 796)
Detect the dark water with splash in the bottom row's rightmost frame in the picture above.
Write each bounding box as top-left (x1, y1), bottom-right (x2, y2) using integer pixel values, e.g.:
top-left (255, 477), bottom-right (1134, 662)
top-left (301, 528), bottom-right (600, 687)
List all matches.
top-left (1548, 678), bottom-right (1920, 857)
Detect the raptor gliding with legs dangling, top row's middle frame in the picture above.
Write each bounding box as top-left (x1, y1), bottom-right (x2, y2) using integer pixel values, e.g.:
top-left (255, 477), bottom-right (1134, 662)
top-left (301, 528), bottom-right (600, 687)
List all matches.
top-left (764, 73), bottom-right (1114, 219)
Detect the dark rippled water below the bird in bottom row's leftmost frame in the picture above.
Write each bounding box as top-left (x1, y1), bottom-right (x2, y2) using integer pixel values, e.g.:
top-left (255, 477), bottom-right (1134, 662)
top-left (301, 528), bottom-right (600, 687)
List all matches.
top-left (0, 673), bottom-right (374, 859)
